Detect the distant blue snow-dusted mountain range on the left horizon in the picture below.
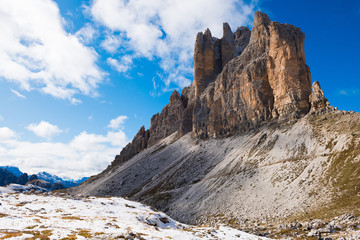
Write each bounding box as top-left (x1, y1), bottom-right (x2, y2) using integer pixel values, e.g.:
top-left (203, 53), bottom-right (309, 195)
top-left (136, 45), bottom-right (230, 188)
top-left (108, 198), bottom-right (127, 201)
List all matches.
top-left (0, 166), bottom-right (88, 188)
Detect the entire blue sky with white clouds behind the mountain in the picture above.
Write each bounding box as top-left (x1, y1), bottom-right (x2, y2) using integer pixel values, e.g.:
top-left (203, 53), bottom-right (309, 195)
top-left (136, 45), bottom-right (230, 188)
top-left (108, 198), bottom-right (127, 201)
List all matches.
top-left (0, 0), bottom-right (360, 178)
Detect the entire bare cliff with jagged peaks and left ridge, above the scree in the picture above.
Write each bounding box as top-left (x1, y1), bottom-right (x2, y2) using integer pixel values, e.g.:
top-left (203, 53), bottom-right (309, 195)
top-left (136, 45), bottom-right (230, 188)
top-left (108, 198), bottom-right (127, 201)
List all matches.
top-left (105, 12), bottom-right (324, 171)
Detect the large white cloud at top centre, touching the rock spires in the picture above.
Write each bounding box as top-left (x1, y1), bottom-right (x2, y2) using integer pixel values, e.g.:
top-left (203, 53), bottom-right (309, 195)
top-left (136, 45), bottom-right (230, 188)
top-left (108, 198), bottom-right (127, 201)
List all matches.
top-left (90, 0), bottom-right (254, 88)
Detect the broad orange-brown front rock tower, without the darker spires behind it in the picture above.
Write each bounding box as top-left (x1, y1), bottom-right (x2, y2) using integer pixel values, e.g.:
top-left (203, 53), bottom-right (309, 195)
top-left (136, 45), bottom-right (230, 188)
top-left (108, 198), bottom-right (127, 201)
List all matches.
top-left (194, 12), bottom-right (311, 137)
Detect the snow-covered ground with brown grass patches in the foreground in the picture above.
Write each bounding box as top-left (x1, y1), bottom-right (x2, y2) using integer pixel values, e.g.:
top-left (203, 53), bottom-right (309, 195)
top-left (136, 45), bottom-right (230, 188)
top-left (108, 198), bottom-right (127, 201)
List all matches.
top-left (0, 191), bottom-right (264, 240)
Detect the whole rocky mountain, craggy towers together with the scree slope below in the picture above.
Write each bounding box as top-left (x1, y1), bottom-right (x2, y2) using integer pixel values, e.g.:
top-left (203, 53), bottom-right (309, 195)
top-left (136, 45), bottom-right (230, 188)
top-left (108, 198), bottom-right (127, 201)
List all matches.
top-left (72, 12), bottom-right (360, 238)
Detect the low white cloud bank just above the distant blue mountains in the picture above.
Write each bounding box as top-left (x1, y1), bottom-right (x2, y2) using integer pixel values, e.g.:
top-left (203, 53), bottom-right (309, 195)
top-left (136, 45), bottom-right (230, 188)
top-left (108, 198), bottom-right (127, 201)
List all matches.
top-left (0, 117), bottom-right (128, 179)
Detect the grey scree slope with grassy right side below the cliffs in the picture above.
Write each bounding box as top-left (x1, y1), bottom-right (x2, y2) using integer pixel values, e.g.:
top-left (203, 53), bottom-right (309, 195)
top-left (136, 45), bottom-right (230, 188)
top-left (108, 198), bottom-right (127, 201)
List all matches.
top-left (73, 111), bottom-right (360, 226)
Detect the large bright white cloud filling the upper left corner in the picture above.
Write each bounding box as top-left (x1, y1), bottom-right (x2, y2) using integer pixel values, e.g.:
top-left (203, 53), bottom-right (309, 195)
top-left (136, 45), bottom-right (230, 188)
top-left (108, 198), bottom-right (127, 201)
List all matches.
top-left (0, 0), bottom-right (104, 100)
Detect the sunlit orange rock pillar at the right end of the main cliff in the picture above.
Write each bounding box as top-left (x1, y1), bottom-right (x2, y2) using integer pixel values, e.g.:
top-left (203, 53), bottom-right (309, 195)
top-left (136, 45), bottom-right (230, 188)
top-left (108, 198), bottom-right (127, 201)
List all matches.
top-left (267, 22), bottom-right (311, 117)
